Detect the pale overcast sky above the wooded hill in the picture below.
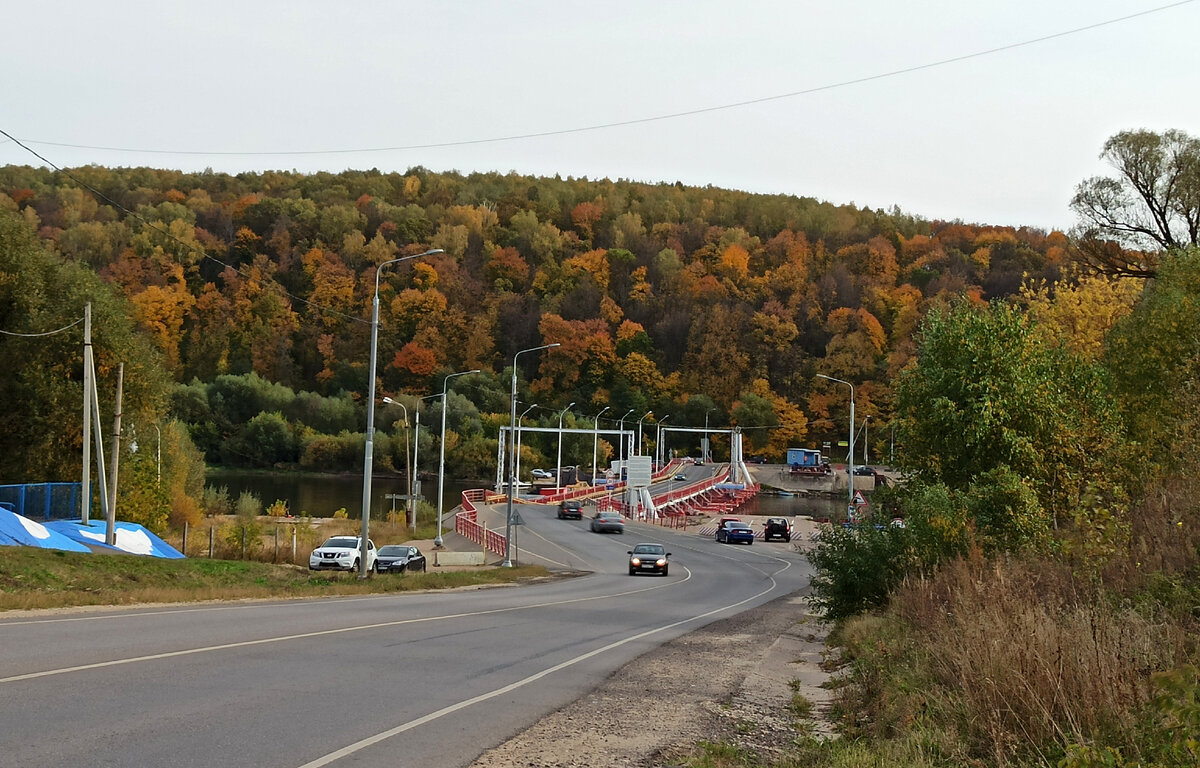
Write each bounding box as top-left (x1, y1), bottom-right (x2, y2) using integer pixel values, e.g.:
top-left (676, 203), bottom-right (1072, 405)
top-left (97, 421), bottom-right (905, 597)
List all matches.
top-left (0, 0), bottom-right (1200, 229)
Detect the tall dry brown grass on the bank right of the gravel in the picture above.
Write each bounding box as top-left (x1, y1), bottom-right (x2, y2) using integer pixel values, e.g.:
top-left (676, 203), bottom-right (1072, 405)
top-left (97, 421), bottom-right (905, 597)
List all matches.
top-left (883, 465), bottom-right (1200, 766)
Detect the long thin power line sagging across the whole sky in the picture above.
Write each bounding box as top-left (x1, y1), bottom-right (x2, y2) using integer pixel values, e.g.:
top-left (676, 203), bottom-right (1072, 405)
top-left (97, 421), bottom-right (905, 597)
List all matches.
top-left (6, 0), bottom-right (1194, 157)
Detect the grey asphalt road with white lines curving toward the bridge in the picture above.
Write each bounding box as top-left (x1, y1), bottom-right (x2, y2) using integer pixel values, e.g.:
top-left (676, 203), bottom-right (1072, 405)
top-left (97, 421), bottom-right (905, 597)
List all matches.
top-left (0, 506), bottom-right (810, 768)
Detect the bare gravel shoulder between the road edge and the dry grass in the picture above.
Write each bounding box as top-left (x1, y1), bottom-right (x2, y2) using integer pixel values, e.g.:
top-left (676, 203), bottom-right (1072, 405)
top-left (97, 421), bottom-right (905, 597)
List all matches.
top-left (472, 592), bottom-right (830, 768)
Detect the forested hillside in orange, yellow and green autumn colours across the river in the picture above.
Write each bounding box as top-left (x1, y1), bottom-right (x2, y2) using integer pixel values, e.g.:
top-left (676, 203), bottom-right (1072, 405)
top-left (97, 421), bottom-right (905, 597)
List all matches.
top-left (0, 166), bottom-right (1069, 475)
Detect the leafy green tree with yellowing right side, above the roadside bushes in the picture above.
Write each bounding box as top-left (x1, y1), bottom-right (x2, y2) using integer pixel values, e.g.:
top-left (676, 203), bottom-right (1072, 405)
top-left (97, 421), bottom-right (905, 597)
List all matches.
top-left (896, 301), bottom-right (1122, 532)
